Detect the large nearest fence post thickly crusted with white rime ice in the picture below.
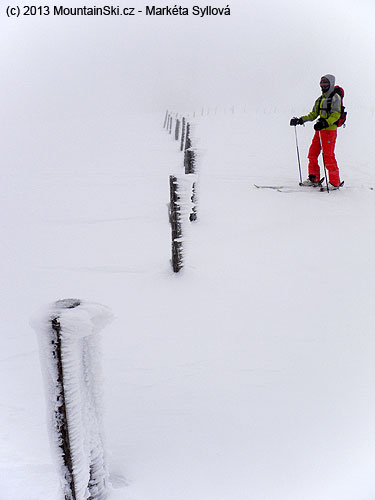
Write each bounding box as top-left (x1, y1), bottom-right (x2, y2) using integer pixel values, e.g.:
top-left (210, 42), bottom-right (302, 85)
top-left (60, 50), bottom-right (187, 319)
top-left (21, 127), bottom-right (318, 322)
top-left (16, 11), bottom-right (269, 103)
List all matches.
top-left (33, 299), bottom-right (112, 500)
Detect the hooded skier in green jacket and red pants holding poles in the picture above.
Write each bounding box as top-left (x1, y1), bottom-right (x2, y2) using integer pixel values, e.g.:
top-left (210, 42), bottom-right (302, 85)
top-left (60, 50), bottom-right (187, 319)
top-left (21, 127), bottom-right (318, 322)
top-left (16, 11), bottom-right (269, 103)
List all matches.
top-left (290, 75), bottom-right (341, 189)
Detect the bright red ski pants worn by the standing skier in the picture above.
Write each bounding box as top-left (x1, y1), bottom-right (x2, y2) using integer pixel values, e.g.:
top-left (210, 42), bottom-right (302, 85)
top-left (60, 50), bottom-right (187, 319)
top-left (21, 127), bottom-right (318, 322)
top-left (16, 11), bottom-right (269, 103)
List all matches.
top-left (308, 130), bottom-right (340, 186)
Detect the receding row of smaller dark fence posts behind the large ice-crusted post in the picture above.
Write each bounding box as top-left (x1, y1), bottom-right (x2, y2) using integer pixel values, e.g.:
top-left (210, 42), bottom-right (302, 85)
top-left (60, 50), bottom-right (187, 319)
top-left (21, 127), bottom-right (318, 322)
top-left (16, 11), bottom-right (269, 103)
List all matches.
top-left (164, 110), bottom-right (197, 273)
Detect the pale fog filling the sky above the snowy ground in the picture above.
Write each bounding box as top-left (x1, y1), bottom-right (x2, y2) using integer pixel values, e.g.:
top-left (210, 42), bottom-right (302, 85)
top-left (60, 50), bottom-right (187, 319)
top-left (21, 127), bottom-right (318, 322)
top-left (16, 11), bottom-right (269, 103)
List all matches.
top-left (0, 0), bottom-right (375, 121)
